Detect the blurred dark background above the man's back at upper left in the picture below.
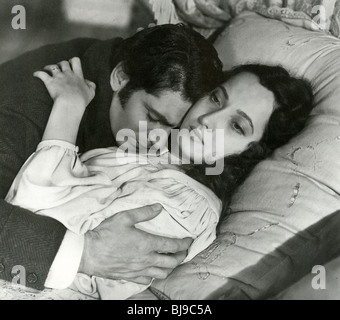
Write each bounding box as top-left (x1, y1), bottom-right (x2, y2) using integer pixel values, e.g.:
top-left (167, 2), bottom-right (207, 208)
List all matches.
top-left (0, 0), bottom-right (153, 63)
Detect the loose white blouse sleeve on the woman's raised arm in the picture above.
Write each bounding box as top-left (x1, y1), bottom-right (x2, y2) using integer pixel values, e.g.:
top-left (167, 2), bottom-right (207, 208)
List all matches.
top-left (6, 140), bottom-right (115, 234)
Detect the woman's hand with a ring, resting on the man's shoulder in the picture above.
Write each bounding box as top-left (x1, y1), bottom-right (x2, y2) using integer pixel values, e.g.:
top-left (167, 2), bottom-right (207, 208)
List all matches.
top-left (34, 58), bottom-right (96, 110)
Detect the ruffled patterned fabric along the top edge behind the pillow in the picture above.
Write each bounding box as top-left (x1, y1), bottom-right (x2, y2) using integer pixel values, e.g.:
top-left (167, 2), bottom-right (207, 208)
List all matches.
top-left (150, 0), bottom-right (340, 37)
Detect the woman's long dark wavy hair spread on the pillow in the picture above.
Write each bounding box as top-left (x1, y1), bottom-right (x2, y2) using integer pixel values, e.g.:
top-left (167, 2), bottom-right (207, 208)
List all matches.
top-left (186, 64), bottom-right (314, 218)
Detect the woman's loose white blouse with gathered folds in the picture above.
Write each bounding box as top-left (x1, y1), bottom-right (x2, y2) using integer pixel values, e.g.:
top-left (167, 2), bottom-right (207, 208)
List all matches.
top-left (6, 140), bottom-right (221, 299)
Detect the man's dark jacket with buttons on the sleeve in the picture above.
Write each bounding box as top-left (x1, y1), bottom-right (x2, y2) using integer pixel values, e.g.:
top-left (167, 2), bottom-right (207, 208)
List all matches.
top-left (0, 39), bottom-right (121, 290)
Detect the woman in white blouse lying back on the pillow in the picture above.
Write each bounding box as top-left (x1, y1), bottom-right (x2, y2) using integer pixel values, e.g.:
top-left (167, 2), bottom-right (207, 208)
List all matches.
top-left (6, 62), bottom-right (312, 299)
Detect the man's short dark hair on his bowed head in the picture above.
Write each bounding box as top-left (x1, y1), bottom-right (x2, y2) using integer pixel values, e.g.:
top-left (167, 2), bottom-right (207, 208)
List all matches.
top-left (112, 24), bottom-right (223, 105)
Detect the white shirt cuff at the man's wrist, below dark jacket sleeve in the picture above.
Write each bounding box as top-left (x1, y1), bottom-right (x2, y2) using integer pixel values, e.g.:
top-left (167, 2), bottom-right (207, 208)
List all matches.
top-left (45, 230), bottom-right (84, 290)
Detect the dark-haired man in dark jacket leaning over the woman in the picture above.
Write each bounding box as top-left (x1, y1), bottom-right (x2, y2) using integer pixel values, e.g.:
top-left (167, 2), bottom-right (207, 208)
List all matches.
top-left (0, 25), bottom-right (222, 290)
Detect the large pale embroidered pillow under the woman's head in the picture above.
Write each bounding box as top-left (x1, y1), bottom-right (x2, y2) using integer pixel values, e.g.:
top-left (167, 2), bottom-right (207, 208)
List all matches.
top-left (151, 12), bottom-right (340, 300)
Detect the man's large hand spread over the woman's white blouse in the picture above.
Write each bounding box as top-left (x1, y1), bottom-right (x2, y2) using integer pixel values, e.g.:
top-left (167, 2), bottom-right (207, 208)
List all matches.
top-left (79, 205), bottom-right (192, 284)
